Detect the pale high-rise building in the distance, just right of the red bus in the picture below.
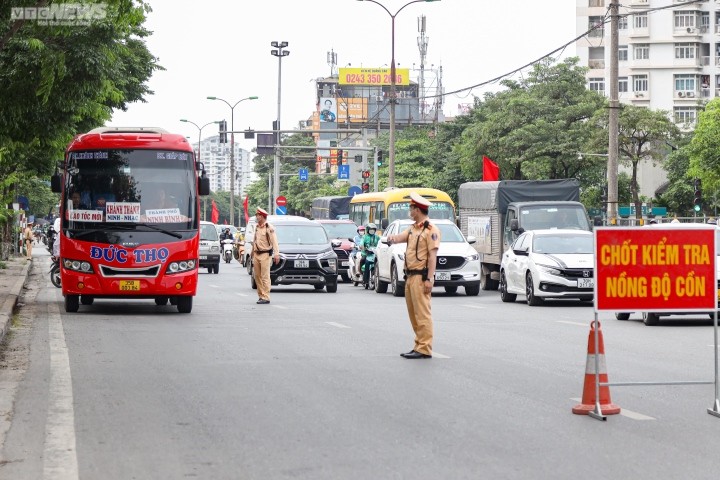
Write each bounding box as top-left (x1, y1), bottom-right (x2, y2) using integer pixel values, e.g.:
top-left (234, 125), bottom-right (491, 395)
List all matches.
top-left (193, 135), bottom-right (257, 196)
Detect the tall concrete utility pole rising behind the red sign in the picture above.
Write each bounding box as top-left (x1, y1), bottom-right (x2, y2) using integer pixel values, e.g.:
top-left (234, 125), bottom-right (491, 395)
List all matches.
top-left (607, 2), bottom-right (620, 225)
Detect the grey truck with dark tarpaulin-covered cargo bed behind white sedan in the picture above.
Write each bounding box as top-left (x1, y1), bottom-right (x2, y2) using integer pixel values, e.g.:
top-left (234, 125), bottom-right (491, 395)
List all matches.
top-left (458, 178), bottom-right (592, 290)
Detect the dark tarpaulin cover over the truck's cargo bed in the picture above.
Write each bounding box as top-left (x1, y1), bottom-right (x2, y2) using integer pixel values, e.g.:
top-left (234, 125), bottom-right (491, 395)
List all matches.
top-left (458, 178), bottom-right (580, 214)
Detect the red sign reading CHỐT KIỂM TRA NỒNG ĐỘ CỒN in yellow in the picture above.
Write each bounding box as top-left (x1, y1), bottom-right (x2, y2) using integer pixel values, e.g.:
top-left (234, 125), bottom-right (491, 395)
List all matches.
top-left (595, 224), bottom-right (718, 312)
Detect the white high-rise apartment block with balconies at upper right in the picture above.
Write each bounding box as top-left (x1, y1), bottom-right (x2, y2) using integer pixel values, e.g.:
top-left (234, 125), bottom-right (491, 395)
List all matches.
top-left (576, 0), bottom-right (720, 197)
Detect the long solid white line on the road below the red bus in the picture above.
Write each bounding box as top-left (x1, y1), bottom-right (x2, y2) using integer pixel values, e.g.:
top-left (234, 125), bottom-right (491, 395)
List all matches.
top-left (43, 302), bottom-right (79, 480)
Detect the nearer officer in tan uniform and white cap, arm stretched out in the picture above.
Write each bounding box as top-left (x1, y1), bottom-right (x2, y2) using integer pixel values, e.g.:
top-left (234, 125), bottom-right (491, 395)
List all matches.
top-left (387, 192), bottom-right (440, 359)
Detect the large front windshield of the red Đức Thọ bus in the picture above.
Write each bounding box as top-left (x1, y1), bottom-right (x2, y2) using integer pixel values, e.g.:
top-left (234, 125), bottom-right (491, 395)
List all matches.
top-left (63, 149), bottom-right (197, 232)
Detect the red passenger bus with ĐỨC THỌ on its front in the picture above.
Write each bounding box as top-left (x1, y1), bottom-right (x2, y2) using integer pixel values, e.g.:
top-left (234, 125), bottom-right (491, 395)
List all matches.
top-left (52, 127), bottom-right (210, 313)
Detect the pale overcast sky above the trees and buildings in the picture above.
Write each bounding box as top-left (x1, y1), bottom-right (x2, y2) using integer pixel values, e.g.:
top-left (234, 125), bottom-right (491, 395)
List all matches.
top-left (108, 0), bottom-right (576, 150)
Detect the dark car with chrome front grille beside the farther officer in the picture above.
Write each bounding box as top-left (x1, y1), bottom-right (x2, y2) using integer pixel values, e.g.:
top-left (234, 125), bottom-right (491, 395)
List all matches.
top-left (250, 216), bottom-right (339, 293)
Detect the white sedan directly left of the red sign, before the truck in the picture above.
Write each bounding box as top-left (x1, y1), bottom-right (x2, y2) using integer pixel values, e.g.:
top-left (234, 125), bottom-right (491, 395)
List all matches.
top-left (500, 229), bottom-right (594, 306)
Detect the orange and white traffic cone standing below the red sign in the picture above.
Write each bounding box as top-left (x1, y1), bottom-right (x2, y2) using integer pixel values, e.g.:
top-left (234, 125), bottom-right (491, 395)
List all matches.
top-left (573, 321), bottom-right (620, 415)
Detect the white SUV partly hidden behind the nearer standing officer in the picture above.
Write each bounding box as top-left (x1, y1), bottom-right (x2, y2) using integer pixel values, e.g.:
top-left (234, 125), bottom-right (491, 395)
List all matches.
top-left (373, 219), bottom-right (480, 297)
